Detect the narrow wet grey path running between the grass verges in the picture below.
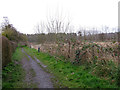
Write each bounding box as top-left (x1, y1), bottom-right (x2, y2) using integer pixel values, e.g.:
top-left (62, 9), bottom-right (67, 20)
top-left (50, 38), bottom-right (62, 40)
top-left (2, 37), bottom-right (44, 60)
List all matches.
top-left (22, 48), bottom-right (53, 88)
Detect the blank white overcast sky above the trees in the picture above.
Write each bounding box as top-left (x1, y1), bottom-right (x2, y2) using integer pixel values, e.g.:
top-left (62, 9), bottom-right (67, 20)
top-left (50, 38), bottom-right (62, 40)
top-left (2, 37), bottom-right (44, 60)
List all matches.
top-left (0, 0), bottom-right (119, 34)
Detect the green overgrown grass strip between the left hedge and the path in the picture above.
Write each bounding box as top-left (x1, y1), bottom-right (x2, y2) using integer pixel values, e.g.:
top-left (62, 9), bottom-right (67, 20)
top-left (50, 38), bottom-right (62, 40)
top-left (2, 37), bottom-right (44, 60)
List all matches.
top-left (2, 47), bottom-right (34, 89)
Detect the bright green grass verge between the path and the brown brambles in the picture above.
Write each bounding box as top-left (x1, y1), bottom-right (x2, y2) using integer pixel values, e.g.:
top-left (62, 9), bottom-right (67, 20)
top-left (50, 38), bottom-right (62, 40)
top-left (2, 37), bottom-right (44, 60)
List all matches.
top-left (24, 47), bottom-right (117, 88)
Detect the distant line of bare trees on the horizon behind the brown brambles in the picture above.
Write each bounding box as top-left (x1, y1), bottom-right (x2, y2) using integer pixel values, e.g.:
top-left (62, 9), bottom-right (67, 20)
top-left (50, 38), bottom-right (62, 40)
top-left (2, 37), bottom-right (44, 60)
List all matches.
top-left (27, 32), bottom-right (118, 43)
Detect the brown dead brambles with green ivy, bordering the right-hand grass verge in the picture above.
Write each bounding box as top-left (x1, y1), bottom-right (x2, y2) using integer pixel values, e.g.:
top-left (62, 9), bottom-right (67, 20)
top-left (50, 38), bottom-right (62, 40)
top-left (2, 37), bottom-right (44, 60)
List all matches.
top-left (29, 42), bottom-right (119, 81)
